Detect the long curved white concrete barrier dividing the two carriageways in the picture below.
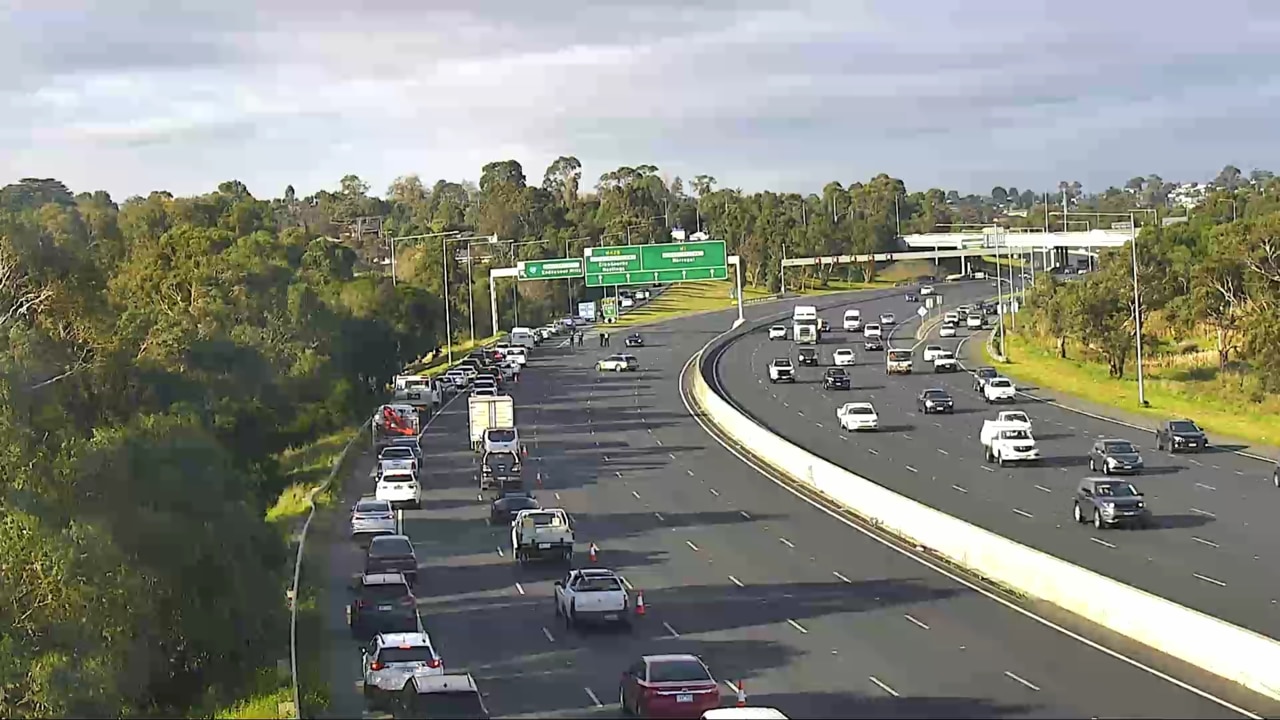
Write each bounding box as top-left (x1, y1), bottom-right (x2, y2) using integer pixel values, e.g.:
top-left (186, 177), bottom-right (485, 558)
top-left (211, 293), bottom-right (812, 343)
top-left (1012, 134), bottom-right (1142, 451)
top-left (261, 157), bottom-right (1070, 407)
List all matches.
top-left (690, 338), bottom-right (1280, 700)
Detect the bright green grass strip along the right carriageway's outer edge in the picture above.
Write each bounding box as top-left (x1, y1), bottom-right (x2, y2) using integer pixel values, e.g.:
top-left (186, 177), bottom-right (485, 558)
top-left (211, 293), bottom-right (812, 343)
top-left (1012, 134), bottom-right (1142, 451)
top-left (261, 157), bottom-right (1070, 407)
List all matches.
top-left (983, 333), bottom-right (1280, 445)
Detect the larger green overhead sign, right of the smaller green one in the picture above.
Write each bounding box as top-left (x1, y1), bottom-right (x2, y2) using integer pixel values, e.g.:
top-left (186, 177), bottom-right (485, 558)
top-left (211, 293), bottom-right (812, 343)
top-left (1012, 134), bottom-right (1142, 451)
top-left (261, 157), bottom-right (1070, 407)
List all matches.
top-left (582, 240), bottom-right (728, 287)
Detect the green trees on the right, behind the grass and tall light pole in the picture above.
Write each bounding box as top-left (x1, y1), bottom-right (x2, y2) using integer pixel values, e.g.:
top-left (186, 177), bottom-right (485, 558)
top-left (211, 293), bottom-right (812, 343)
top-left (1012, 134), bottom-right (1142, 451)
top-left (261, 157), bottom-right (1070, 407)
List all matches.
top-left (1024, 174), bottom-right (1280, 401)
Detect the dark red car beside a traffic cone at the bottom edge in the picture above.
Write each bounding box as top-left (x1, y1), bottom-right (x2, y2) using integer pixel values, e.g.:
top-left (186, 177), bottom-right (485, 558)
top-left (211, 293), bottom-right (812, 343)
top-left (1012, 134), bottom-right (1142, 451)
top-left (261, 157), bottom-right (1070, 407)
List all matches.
top-left (618, 655), bottom-right (719, 717)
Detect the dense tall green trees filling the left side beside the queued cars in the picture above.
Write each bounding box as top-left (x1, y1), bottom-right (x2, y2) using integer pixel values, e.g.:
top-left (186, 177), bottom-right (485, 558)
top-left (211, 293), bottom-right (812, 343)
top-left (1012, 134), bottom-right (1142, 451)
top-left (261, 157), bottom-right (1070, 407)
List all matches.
top-left (0, 181), bottom-right (443, 717)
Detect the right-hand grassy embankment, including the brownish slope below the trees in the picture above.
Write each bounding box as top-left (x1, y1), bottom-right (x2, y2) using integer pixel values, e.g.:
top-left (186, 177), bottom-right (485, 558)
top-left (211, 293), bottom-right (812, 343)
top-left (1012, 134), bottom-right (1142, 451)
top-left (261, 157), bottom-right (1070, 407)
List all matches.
top-left (983, 318), bottom-right (1280, 445)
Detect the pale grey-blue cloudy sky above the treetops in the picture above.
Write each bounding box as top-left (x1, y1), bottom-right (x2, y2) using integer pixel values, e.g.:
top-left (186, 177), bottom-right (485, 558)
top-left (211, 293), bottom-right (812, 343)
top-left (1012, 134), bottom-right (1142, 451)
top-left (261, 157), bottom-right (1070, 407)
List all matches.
top-left (0, 0), bottom-right (1280, 199)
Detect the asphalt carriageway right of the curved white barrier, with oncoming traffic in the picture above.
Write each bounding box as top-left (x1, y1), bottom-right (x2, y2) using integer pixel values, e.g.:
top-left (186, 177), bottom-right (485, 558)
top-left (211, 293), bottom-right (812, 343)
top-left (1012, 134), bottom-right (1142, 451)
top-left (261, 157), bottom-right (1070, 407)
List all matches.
top-left (717, 286), bottom-right (1280, 702)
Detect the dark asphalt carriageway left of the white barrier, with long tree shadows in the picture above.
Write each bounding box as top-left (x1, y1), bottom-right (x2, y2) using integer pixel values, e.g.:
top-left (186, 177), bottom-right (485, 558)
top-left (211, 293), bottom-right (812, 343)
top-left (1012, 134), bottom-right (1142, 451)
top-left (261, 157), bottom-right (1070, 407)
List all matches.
top-left (320, 288), bottom-right (1272, 717)
